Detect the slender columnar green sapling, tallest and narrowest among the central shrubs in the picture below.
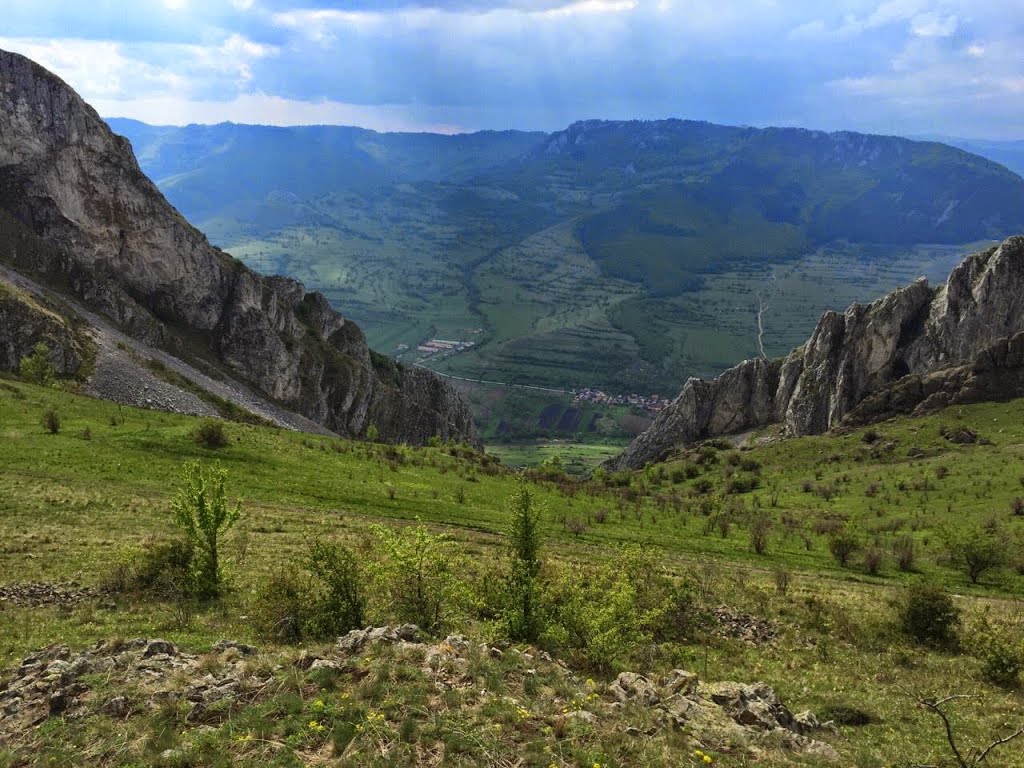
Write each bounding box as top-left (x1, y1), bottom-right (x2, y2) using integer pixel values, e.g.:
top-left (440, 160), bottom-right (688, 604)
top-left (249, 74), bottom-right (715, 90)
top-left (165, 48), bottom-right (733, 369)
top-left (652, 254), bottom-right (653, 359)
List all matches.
top-left (507, 482), bottom-right (541, 642)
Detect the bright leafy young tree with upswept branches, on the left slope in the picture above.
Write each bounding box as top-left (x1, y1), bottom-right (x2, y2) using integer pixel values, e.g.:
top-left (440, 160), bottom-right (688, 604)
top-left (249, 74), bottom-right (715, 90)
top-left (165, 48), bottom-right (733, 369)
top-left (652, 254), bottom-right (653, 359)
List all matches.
top-left (171, 462), bottom-right (242, 597)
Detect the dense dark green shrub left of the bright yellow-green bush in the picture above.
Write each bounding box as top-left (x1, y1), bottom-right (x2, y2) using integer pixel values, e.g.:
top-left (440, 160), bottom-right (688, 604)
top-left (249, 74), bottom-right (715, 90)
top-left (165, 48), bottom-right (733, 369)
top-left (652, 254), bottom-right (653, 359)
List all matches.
top-left (303, 541), bottom-right (367, 639)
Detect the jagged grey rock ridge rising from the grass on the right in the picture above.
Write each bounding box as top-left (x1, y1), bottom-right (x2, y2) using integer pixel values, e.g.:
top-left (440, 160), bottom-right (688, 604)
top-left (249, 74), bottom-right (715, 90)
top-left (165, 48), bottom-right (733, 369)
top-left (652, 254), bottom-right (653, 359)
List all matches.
top-left (606, 237), bottom-right (1024, 469)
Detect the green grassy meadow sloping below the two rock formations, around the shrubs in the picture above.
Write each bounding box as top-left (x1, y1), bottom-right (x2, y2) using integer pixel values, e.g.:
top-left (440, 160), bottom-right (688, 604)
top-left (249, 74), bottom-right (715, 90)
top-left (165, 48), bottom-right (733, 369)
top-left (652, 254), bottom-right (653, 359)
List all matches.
top-left (0, 379), bottom-right (1024, 766)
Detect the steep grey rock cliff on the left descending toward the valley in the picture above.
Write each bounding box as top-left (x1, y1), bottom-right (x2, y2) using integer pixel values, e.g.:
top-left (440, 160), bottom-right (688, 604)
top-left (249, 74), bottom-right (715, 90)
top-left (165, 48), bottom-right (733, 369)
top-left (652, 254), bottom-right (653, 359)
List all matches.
top-left (0, 51), bottom-right (478, 443)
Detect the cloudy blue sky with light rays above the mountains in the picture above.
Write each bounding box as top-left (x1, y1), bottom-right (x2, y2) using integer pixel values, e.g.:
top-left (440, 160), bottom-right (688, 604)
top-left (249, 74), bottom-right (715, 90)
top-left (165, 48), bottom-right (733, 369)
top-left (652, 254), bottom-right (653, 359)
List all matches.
top-left (0, 0), bottom-right (1024, 139)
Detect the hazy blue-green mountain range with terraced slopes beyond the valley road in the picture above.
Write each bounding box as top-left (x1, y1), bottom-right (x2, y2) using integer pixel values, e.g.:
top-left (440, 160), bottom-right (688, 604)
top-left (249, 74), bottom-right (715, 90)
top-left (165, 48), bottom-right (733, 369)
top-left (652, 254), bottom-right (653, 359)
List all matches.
top-left (111, 120), bottom-right (1024, 395)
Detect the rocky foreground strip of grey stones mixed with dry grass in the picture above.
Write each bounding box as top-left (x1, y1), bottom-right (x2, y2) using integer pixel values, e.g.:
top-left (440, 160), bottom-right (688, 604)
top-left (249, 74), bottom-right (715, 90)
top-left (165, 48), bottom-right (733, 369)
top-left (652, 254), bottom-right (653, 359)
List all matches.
top-left (0, 625), bottom-right (839, 763)
